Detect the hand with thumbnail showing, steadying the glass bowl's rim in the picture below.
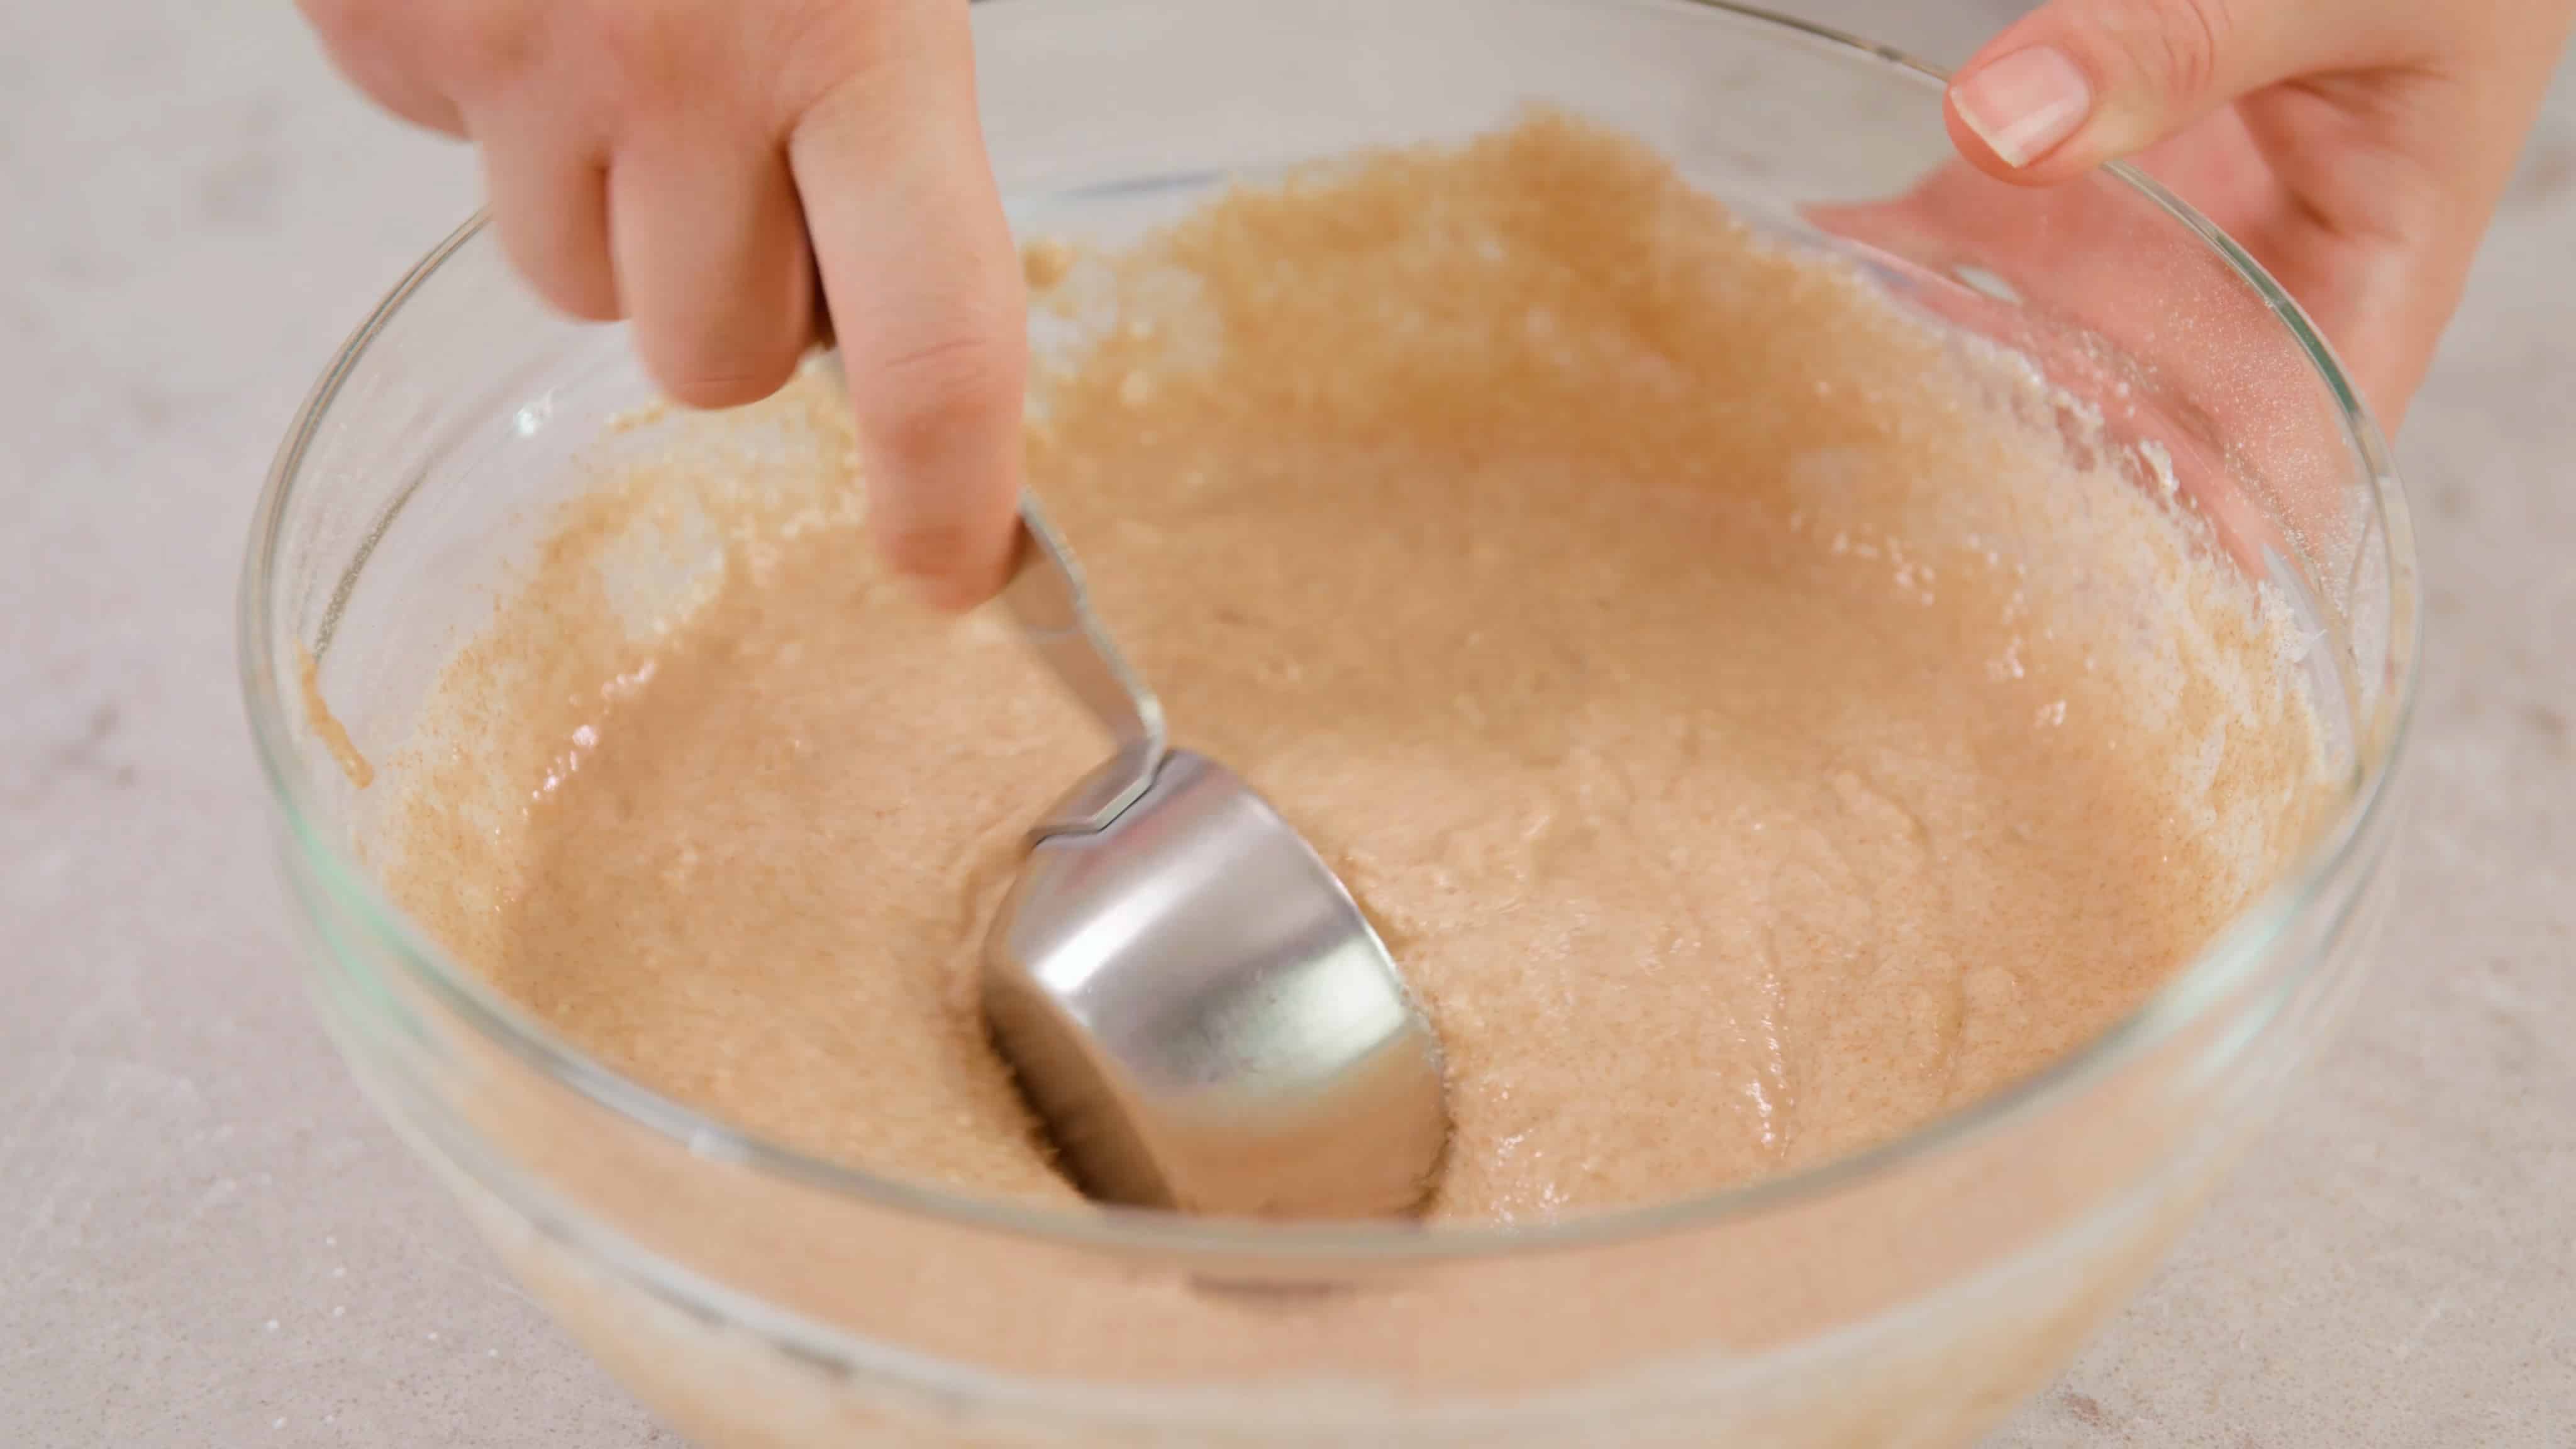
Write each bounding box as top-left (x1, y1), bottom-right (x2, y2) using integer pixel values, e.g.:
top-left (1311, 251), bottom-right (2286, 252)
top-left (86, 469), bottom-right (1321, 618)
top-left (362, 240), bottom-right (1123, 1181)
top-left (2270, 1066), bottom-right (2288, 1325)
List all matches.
top-left (1948, 0), bottom-right (2576, 431)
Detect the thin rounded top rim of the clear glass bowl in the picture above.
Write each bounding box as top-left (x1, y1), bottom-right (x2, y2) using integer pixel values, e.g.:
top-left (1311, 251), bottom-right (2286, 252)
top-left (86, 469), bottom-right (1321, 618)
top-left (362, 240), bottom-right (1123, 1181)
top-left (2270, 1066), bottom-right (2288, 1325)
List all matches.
top-left (237, 0), bottom-right (2421, 1263)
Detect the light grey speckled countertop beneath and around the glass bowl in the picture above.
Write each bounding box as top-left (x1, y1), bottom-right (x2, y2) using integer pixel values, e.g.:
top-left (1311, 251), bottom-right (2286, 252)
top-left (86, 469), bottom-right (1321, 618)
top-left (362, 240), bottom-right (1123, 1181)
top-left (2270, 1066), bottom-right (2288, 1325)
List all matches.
top-left (0, 0), bottom-right (2576, 1449)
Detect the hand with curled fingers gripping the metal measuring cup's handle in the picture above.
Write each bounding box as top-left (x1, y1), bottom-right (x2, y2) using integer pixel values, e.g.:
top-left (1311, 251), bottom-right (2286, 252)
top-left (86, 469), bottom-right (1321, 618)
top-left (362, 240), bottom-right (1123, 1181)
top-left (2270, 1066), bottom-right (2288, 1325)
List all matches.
top-left (299, 0), bottom-right (1028, 609)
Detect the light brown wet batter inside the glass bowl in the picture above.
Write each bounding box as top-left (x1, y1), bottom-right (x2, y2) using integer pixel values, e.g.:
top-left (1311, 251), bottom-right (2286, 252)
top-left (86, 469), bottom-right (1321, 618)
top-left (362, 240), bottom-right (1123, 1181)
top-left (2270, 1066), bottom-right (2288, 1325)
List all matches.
top-left (386, 119), bottom-right (2324, 1219)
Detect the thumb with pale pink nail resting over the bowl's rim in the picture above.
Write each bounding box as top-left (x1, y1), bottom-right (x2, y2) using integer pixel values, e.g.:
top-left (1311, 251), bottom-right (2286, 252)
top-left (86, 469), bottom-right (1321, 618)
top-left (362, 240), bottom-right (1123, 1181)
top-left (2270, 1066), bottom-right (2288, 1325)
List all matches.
top-left (1948, 0), bottom-right (2393, 186)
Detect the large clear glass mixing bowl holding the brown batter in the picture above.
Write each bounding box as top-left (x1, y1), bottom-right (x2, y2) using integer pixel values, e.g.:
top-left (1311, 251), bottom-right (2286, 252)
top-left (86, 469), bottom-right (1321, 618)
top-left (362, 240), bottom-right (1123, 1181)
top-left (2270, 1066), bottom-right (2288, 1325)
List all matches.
top-left (242, 0), bottom-right (2416, 1446)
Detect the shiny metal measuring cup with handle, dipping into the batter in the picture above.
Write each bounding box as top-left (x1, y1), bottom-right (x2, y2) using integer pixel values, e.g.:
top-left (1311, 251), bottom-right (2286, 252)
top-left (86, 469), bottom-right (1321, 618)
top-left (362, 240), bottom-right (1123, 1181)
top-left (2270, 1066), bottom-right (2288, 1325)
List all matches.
top-left (984, 495), bottom-right (1448, 1217)
